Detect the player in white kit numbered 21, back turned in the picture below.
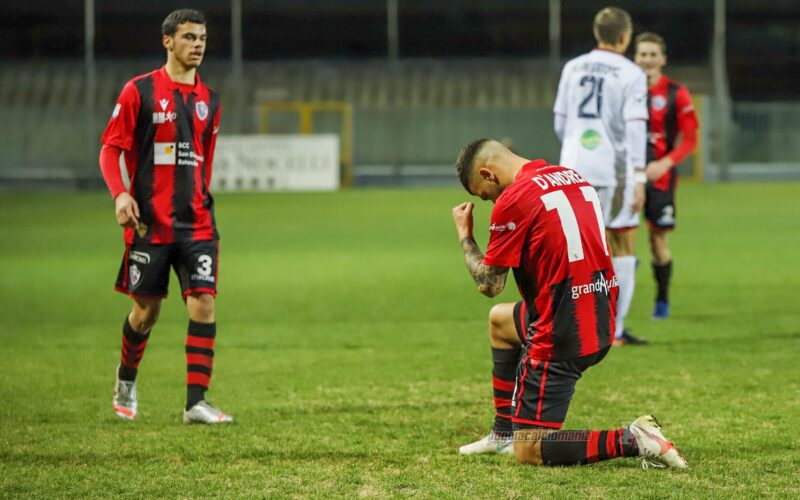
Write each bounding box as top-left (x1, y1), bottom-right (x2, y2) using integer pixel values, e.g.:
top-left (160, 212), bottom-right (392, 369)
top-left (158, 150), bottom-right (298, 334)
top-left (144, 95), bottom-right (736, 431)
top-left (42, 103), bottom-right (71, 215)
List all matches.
top-left (553, 7), bottom-right (648, 345)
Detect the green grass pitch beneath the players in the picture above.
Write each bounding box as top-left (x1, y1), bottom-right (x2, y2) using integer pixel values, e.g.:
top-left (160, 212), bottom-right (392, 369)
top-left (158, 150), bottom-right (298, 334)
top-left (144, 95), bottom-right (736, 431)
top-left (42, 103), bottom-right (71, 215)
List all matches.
top-left (0, 184), bottom-right (800, 498)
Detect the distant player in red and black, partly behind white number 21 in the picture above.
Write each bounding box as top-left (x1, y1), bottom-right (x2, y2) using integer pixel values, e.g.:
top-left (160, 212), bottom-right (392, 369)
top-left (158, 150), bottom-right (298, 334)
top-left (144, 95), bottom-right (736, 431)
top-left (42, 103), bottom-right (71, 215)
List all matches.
top-left (635, 32), bottom-right (697, 319)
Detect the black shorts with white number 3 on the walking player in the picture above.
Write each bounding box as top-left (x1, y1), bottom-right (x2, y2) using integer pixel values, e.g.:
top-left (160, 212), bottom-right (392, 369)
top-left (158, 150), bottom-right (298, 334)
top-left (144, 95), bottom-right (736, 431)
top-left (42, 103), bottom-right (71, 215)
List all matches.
top-left (114, 240), bottom-right (219, 297)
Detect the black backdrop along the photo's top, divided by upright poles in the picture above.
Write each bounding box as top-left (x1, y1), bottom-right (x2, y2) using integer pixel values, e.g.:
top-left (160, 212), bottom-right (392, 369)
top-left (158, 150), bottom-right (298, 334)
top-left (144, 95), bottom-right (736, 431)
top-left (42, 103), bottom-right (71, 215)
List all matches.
top-left (0, 0), bottom-right (800, 100)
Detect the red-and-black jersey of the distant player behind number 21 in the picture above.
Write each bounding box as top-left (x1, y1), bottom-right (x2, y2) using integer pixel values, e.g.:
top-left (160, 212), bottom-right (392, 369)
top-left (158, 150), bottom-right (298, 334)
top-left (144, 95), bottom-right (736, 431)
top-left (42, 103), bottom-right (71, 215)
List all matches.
top-left (647, 75), bottom-right (697, 190)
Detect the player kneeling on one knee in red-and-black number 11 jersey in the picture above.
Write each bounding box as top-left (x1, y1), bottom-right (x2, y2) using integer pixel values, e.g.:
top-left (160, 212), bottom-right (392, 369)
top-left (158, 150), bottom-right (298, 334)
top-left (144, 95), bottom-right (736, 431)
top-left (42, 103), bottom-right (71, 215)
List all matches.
top-left (453, 139), bottom-right (688, 468)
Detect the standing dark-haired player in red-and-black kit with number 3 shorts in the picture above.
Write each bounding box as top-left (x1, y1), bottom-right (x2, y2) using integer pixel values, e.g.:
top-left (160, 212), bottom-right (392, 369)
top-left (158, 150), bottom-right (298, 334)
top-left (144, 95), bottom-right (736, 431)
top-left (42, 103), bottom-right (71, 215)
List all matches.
top-left (100, 9), bottom-right (233, 424)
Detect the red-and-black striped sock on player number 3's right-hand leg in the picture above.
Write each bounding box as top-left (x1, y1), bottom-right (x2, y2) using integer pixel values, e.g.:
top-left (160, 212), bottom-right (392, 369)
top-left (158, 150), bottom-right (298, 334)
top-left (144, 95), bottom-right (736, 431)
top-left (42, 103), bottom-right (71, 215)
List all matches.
top-left (186, 321), bottom-right (217, 410)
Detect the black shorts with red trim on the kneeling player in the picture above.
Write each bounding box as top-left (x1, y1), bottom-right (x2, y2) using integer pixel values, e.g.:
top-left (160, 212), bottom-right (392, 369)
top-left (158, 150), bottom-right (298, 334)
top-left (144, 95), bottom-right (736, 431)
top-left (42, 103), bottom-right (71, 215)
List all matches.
top-left (511, 302), bottom-right (610, 430)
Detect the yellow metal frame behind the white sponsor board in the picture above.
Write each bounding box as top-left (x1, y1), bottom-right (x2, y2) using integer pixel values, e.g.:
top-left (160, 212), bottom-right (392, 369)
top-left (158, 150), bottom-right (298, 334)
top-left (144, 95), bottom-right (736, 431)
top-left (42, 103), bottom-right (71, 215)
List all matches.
top-left (260, 101), bottom-right (353, 187)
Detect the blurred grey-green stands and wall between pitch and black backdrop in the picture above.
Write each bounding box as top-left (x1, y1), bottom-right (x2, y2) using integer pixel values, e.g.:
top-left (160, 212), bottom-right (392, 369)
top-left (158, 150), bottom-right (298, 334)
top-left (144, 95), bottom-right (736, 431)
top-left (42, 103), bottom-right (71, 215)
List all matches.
top-left (0, 60), bottom-right (800, 184)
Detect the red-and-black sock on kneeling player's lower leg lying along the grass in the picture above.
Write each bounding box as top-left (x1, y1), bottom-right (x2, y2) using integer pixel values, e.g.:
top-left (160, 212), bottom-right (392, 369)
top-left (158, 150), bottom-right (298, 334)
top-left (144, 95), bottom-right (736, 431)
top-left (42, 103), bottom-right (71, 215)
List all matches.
top-left (541, 428), bottom-right (639, 465)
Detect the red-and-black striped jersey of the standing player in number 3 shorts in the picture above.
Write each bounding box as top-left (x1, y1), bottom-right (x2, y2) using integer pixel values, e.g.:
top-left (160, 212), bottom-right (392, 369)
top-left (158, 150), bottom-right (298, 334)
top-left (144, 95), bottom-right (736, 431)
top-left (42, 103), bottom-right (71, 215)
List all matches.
top-left (101, 67), bottom-right (222, 244)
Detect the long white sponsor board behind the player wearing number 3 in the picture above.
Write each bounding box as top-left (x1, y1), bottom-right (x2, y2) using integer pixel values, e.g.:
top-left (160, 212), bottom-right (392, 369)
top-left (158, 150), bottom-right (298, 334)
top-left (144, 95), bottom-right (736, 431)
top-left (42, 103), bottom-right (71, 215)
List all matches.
top-left (211, 134), bottom-right (340, 191)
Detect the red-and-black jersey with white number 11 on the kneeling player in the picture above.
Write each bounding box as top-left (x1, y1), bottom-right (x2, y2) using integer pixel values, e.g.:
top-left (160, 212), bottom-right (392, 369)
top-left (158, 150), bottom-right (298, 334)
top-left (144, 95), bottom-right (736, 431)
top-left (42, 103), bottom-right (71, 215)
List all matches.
top-left (483, 160), bottom-right (619, 360)
